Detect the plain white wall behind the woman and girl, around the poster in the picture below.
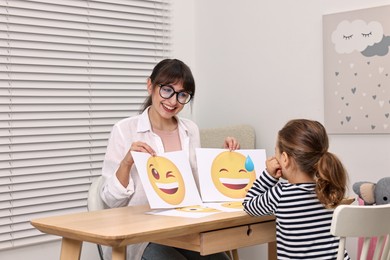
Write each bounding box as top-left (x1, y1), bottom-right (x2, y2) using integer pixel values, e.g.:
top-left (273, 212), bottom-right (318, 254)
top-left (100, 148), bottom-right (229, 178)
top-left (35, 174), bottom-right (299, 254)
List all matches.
top-left (0, 0), bottom-right (390, 260)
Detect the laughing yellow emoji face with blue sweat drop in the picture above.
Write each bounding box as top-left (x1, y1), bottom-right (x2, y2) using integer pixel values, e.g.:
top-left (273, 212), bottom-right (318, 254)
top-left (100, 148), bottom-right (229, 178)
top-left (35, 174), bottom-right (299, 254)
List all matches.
top-left (211, 151), bottom-right (256, 199)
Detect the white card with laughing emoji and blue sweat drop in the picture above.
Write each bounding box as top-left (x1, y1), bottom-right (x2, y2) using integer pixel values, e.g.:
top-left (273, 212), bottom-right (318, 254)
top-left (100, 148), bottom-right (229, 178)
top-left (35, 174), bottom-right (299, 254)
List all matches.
top-left (196, 148), bottom-right (266, 202)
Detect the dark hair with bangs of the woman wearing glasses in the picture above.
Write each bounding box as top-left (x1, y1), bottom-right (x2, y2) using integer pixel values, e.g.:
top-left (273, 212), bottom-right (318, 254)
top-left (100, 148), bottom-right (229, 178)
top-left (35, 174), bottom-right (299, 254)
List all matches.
top-left (141, 59), bottom-right (195, 111)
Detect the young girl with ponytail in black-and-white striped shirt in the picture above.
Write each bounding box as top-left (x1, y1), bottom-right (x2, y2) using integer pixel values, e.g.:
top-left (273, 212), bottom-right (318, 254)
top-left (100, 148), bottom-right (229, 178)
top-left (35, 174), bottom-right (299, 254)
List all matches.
top-left (243, 119), bottom-right (349, 260)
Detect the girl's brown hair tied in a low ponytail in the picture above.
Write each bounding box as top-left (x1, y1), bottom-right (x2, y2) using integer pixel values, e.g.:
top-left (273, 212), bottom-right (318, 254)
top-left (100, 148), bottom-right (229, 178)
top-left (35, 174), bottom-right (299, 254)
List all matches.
top-left (277, 119), bottom-right (348, 208)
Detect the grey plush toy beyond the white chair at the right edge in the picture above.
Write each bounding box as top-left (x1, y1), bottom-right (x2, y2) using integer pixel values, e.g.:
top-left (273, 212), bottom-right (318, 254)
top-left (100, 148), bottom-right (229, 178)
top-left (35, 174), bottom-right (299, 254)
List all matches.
top-left (352, 177), bottom-right (390, 205)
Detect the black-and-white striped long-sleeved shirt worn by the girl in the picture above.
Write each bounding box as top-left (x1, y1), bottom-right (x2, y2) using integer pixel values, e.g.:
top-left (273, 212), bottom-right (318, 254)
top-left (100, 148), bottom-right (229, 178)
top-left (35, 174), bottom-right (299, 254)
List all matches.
top-left (243, 171), bottom-right (350, 260)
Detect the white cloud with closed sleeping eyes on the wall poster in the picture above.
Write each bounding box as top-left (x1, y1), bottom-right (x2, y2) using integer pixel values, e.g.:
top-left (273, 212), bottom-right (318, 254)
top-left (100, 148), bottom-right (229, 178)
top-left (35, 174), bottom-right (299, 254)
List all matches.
top-left (332, 20), bottom-right (383, 54)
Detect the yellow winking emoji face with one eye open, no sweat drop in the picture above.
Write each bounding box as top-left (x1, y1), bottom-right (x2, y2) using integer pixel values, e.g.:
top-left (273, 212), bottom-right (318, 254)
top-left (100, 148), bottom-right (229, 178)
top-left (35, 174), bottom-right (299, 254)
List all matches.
top-left (147, 156), bottom-right (185, 205)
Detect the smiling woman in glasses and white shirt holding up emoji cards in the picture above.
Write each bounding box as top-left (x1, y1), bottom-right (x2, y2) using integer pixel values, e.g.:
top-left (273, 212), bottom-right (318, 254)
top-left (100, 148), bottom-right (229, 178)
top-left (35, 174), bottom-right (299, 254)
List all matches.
top-left (101, 59), bottom-right (239, 260)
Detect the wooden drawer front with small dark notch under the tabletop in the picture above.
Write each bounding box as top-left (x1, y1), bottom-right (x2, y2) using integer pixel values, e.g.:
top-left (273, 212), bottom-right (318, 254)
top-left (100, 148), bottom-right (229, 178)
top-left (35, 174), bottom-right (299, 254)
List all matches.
top-left (200, 221), bottom-right (276, 255)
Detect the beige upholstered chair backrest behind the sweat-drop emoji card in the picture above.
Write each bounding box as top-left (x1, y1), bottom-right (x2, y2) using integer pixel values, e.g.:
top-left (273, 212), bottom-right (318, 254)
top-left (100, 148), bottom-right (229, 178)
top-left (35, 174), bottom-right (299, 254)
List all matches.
top-left (200, 124), bottom-right (256, 149)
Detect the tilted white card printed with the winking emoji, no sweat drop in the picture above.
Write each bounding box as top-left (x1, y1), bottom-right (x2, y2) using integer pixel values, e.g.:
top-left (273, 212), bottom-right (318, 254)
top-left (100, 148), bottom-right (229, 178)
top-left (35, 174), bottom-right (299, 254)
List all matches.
top-left (131, 151), bottom-right (202, 209)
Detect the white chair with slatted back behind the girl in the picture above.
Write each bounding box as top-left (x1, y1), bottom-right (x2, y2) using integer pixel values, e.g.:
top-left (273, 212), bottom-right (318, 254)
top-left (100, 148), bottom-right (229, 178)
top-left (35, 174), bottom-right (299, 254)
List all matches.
top-left (330, 204), bottom-right (390, 260)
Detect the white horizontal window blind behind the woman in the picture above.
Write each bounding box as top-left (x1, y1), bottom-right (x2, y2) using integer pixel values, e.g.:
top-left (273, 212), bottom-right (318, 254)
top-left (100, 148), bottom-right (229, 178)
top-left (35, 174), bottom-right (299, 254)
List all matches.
top-left (0, 0), bottom-right (170, 250)
